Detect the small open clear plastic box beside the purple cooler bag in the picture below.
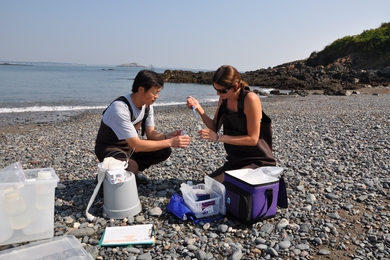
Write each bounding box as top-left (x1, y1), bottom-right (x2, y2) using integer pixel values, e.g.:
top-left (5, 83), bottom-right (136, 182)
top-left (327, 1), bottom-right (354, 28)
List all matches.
top-left (180, 176), bottom-right (226, 218)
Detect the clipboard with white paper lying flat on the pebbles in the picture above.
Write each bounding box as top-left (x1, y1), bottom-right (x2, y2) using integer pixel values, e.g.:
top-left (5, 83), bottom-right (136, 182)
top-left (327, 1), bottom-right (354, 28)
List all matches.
top-left (99, 224), bottom-right (156, 246)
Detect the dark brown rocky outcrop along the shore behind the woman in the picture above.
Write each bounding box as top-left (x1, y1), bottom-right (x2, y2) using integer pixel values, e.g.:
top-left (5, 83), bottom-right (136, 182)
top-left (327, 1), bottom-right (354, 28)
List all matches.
top-left (162, 57), bottom-right (390, 95)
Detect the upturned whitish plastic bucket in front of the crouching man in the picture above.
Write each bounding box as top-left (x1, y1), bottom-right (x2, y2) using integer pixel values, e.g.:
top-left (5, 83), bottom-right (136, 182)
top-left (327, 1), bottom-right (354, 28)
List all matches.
top-left (103, 171), bottom-right (142, 219)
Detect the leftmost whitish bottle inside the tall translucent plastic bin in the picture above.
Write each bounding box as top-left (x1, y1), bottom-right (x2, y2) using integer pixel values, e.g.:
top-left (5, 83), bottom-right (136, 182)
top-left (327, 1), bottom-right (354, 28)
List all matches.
top-left (4, 190), bottom-right (30, 230)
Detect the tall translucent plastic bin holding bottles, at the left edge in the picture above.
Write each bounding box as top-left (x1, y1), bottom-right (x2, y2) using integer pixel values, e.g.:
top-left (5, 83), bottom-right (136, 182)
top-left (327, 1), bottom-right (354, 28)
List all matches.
top-left (0, 168), bottom-right (59, 246)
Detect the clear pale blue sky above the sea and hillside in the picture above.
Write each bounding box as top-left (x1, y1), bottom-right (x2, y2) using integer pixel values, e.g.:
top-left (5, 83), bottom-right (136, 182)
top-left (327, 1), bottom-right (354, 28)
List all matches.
top-left (0, 0), bottom-right (390, 71)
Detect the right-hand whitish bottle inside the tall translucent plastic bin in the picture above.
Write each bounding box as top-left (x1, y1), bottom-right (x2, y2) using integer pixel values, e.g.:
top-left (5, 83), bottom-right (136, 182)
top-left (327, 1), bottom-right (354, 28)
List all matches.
top-left (35, 171), bottom-right (54, 210)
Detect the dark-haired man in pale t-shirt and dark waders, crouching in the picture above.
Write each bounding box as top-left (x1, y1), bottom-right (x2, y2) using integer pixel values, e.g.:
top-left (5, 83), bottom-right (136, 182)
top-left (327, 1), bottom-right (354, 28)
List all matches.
top-left (95, 70), bottom-right (190, 184)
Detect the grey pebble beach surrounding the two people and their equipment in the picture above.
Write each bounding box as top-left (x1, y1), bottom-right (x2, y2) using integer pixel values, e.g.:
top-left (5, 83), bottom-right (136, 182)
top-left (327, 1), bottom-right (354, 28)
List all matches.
top-left (0, 93), bottom-right (390, 260)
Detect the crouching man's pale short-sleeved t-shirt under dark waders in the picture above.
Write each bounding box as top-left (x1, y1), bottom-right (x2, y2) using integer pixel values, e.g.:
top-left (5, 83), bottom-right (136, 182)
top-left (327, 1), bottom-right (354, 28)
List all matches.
top-left (102, 94), bottom-right (154, 140)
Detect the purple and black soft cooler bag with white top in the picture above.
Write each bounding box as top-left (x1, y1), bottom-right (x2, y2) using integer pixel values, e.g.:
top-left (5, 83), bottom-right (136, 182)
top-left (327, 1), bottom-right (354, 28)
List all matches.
top-left (224, 167), bottom-right (283, 222)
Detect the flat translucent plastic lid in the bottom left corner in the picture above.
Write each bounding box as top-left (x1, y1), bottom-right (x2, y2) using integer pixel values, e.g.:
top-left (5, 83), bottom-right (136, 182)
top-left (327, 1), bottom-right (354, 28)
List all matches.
top-left (0, 235), bottom-right (93, 260)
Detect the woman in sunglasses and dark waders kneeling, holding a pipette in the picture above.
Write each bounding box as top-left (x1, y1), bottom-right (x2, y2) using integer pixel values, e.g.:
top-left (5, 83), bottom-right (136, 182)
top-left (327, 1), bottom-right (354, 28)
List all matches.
top-left (187, 65), bottom-right (276, 182)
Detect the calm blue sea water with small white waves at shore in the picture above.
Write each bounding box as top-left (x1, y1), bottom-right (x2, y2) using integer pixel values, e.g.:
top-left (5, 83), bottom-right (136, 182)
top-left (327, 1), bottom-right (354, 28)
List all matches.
top-left (0, 65), bottom-right (270, 113)
